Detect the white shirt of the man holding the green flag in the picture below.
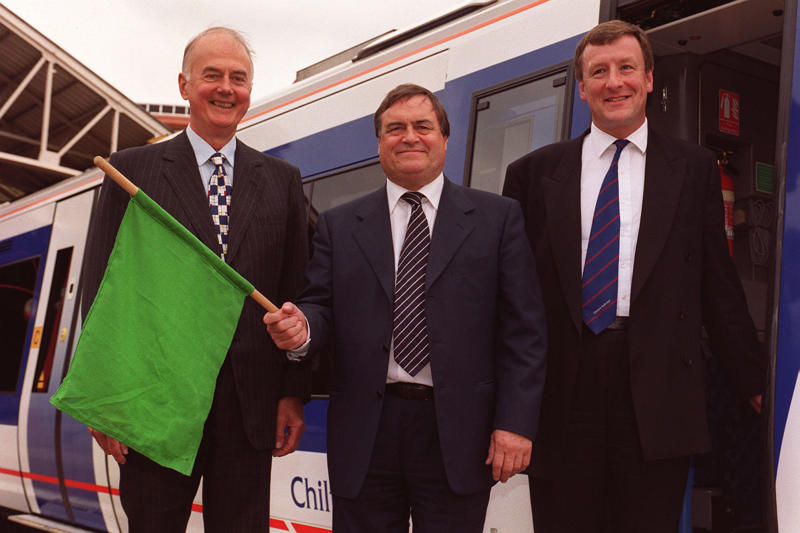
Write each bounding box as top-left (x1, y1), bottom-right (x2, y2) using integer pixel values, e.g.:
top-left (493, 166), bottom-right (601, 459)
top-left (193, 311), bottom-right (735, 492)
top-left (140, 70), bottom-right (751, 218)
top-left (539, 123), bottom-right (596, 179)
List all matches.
top-left (386, 174), bottom-right (444, 386)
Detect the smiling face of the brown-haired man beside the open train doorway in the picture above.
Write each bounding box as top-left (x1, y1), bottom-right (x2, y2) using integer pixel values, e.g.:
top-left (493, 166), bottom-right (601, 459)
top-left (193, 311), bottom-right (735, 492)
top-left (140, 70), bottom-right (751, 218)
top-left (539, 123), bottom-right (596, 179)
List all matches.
top-left (578, 35), bottom-right (653, 139)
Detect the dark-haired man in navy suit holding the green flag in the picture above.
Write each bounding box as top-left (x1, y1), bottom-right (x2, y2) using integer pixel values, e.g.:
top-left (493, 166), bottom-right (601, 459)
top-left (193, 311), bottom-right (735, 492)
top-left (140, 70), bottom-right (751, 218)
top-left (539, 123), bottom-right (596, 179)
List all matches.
top-left (264, 85), bottom-right (545, 533)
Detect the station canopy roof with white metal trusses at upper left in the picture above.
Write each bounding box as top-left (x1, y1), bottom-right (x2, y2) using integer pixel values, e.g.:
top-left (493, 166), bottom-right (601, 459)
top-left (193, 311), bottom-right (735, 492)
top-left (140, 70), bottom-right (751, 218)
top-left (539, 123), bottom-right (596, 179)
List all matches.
top-left (0, 4), bottom-right (170, 204)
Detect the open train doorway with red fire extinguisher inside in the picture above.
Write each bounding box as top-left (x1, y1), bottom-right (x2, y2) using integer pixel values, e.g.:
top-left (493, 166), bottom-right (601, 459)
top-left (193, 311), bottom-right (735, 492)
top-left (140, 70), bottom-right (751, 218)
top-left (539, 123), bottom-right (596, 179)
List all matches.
top-left (603, 0), bottom-right (800, 533)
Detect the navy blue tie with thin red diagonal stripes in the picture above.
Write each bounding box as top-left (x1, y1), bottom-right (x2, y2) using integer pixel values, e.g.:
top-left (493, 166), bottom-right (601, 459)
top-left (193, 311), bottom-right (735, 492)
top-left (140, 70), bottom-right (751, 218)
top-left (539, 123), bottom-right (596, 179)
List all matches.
top-left (581, 139), bottom-right (630, 334)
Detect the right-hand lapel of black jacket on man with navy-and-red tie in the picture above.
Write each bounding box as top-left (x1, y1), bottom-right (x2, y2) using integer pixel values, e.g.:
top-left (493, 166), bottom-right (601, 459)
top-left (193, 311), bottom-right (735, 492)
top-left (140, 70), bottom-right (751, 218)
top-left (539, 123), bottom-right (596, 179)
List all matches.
top-left (631, 129), bottom-right (686, 304)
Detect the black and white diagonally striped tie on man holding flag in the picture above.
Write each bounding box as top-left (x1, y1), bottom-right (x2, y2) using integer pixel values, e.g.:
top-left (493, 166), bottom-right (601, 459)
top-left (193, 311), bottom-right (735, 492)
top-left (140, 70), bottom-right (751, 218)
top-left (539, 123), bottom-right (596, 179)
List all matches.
top-left (392, 192), bottom-right (431, 376)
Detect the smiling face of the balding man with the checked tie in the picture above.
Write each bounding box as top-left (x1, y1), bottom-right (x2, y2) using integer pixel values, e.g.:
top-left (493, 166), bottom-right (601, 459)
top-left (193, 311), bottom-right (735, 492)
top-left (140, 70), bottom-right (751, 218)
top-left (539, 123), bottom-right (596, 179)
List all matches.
top-left (178, 33), bottom-right (252, 149)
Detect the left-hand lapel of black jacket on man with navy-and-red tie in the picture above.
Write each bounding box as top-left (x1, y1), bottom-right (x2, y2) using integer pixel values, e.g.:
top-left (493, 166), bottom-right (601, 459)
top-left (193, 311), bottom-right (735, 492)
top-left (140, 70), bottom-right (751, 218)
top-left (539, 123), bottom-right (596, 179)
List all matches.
top-left (542, 134), bottom-right (586, 334)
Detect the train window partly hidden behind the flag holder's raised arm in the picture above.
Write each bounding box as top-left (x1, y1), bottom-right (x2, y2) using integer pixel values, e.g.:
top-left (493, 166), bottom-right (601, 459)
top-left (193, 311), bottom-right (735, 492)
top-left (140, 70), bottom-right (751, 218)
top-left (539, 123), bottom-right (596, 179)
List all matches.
top-left (303, 162), bottom-right (385, 398)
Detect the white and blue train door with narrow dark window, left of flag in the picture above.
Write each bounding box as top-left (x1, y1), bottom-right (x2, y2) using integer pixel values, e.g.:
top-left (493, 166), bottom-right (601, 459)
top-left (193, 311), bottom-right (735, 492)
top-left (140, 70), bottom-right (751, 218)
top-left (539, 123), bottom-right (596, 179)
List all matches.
top-left (16, 190), bottom-right (116, 529)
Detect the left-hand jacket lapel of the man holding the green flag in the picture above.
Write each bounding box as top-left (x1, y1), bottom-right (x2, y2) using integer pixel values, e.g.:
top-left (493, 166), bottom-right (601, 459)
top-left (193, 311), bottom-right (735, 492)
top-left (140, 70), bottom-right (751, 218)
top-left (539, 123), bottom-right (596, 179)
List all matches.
top-left (353, 187), bottom-right (394, 303)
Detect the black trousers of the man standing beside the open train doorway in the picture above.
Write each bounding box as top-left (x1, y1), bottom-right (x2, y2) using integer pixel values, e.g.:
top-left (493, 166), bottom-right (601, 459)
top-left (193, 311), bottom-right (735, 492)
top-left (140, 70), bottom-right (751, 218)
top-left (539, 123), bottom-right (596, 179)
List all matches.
top-left (530, 327), bottom-right (689, 533)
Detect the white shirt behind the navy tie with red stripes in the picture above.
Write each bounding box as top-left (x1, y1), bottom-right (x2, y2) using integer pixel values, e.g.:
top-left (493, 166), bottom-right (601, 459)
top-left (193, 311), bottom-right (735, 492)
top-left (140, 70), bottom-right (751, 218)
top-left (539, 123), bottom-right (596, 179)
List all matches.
top-left (581, 119), bottom-right (647, 316)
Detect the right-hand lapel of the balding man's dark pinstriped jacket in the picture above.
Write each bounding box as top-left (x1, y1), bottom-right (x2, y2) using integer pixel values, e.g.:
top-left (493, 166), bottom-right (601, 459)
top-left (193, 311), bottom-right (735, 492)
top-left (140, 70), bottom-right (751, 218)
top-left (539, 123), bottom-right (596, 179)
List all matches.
top-left (226, 140), bottom-right (270, 263)
